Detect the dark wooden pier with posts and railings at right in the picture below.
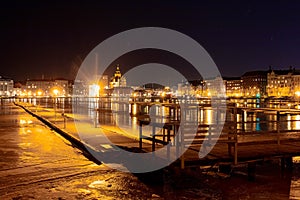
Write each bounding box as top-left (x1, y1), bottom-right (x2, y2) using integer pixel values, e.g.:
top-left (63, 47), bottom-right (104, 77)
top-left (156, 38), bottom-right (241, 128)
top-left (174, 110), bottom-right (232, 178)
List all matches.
top-left (15, 95), bottom-right (300, 180)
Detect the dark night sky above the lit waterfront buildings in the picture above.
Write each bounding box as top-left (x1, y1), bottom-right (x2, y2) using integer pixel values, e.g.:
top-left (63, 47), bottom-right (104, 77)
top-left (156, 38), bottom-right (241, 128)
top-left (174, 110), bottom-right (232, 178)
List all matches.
top-left (0, 1), bottom-right (300, 80)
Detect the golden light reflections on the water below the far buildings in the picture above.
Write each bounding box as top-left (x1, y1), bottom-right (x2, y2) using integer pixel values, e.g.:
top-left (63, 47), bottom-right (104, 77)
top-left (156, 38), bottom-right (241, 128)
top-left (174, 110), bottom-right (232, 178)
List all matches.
top-left (16, 97), bottom-right (300, 132)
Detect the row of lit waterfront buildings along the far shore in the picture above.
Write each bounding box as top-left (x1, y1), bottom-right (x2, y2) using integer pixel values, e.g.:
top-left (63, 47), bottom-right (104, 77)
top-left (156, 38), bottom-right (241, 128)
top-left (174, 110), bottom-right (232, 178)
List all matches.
top-left (7, 66), bottom-right (300, 100)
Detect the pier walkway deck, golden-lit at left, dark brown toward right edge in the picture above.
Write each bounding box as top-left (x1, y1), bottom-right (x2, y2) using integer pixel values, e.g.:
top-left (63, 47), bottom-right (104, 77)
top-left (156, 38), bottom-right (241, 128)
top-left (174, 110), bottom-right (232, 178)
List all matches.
top-left (13, 102), bottom-right (300, 175)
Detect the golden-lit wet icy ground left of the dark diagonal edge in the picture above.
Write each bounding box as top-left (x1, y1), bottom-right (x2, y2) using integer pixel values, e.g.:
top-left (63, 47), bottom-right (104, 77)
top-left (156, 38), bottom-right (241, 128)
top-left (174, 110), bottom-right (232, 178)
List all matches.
top-left (0, 104), bottom-right (161, 199)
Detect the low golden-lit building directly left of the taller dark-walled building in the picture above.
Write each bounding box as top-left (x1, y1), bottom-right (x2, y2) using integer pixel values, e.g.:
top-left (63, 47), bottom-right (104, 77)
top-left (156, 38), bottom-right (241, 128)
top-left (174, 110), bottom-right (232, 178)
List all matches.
top-left (223, 77), bottom-right (244, 97)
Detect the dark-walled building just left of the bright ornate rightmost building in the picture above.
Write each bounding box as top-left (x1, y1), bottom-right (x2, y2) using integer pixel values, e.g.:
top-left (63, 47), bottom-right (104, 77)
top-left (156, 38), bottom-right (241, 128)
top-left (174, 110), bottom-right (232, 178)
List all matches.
top-left (241, 71), bottom-right (268, 97)
